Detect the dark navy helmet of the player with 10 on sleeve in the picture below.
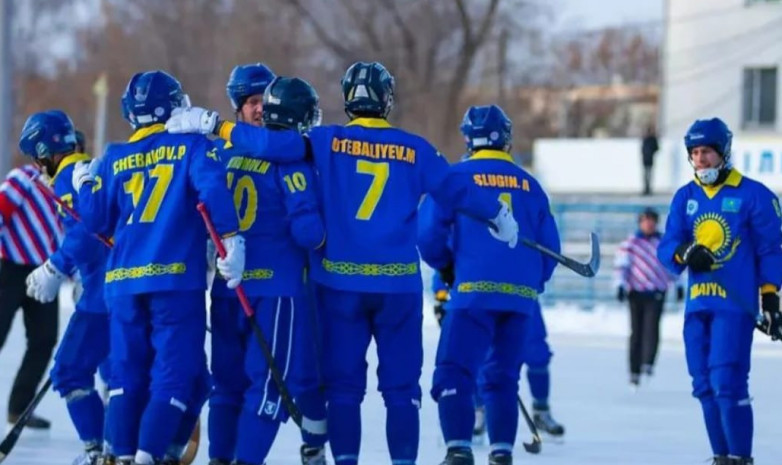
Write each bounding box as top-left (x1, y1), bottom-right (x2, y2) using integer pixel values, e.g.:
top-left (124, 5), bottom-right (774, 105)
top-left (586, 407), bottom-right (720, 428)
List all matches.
top-left (263, 76), bottom-right (321, 132)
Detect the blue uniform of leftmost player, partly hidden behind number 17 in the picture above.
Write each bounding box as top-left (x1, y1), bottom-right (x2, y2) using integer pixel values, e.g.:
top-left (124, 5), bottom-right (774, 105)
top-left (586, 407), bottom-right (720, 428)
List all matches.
top-left (45, 153), bottom-right (109, 448)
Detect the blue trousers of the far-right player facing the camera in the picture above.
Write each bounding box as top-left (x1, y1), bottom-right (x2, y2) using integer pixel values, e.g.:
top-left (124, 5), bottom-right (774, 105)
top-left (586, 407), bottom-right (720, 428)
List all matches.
top-left (684, 311), bottom-right (755, 457)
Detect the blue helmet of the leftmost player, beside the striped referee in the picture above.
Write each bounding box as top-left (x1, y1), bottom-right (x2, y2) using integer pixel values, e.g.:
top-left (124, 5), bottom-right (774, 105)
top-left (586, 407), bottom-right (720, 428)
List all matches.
top-left (19, 110), bottom-right (76, 160)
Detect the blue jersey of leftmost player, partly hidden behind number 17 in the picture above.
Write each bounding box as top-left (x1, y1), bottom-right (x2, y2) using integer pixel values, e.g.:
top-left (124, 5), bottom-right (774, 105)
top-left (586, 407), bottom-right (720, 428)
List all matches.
top-left (50, 153), bottom-right (109, 313)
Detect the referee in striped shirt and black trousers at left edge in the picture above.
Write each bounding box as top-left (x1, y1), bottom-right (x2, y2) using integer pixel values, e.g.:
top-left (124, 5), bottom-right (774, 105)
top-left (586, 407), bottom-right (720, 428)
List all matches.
top-left (0, 165), bottom-right (63, 429)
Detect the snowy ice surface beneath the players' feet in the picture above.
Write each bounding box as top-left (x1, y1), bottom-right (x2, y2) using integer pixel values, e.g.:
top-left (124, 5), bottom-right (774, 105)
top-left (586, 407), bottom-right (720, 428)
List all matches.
top-left (0, 282), bottom-right (782, 465)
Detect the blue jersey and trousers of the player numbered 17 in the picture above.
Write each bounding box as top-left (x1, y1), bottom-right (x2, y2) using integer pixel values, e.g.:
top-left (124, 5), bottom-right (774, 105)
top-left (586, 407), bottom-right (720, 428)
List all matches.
top-left (78, 124), bottom-right (238, 459)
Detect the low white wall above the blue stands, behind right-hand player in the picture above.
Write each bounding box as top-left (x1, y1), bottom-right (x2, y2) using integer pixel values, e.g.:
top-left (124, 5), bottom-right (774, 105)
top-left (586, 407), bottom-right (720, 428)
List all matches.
top-left (533, 137), bottom-right (782, 195)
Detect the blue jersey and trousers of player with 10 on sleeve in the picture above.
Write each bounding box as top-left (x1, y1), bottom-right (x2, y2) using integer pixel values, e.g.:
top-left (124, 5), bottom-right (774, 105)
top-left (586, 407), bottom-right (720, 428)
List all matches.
top-left (209, 141), bottom-right (326, 463)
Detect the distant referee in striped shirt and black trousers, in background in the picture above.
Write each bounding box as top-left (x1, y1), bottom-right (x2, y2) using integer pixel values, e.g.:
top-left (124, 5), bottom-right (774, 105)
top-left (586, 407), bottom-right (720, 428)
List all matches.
top-left (614, 208), bottom-right (684, 387)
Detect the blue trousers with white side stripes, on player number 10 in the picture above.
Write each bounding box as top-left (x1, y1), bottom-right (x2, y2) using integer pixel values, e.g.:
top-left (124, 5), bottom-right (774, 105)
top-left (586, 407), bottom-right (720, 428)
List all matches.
top-left (209, 297), bottom-right (326, 464)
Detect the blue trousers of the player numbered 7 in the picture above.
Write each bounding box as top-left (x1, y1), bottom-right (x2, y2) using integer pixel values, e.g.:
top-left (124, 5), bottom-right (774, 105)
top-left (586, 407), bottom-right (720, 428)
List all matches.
top-left (317, 286), bottom-right (423, 465)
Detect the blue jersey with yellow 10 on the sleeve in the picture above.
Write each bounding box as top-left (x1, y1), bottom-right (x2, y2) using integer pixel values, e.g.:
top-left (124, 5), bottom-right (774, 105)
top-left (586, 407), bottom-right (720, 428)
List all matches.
top-left (212, 140), bottom-right (326, 297)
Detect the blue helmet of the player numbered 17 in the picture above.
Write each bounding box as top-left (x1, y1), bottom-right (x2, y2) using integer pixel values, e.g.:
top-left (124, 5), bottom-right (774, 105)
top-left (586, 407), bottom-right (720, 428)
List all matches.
top-left (122, 70), bottom-right (190, 129)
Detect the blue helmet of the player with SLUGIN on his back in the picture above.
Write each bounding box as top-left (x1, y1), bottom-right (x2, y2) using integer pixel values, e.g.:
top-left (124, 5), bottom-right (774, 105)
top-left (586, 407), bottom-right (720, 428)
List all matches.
top-left (459, 105), bottom-right (513, 151)
